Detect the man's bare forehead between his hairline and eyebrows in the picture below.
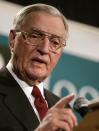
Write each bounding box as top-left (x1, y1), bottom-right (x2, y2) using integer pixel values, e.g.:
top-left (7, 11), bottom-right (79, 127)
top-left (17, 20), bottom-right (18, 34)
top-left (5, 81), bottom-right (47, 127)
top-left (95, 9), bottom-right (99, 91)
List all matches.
top-left (21, 11), bottom-right (66, 37)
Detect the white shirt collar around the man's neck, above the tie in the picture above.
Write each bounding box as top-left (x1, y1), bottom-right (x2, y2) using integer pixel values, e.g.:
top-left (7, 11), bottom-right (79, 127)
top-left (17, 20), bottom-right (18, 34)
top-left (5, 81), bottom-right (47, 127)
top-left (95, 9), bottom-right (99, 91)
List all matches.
top-left (6, 60), bottom-right (44, 98)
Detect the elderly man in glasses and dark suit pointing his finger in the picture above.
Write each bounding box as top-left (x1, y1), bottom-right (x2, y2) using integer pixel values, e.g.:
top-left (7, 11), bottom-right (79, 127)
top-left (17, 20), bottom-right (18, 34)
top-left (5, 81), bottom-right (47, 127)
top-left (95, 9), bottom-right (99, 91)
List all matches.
top-left (0, 4), bottom-right (77, 131)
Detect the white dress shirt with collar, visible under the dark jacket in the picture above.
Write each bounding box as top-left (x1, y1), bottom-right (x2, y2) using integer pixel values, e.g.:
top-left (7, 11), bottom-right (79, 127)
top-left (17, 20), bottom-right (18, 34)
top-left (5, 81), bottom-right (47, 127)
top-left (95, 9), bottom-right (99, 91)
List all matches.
top-left (6, 61), bottom-right (45, 121)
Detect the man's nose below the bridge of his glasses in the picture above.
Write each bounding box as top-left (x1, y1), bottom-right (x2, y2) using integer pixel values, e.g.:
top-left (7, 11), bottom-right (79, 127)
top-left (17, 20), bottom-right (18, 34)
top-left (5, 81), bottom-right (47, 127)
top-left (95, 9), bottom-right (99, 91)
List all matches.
top-left (38, 37), bottom-right (50, 54)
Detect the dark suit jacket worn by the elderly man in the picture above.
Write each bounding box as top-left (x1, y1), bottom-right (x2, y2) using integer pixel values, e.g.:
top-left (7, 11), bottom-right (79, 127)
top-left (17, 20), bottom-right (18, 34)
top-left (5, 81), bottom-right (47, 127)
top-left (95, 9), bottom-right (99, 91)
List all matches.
top-left (0, 68), bottom-right (70, 131)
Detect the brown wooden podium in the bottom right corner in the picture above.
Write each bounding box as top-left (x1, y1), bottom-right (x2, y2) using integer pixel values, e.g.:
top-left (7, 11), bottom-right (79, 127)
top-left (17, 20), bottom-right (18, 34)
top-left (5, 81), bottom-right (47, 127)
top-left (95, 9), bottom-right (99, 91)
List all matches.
top-left (73, 101), bottom-right (99, 131)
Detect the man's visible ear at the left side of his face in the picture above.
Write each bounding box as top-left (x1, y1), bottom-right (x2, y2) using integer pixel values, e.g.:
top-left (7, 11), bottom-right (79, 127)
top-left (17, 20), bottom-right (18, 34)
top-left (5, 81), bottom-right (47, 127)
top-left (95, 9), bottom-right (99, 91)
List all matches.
top-left (9, 30), bottom-right (15, 53)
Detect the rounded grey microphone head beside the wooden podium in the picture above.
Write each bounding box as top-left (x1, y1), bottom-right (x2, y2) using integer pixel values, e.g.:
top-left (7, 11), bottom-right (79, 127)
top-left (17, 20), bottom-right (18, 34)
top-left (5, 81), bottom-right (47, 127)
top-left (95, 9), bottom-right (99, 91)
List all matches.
top-left (73, 97), bottom-right (89, 117)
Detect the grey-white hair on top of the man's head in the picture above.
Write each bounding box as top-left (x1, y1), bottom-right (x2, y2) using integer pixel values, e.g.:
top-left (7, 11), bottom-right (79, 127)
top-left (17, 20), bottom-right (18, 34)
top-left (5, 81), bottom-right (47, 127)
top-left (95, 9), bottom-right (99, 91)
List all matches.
top-left (13, 3), bottom-right (68, 32)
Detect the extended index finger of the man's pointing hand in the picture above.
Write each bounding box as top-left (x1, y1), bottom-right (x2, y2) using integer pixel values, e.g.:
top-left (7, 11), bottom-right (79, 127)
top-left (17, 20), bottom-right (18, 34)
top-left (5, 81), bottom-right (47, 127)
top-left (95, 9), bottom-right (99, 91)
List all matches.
top-left (54, 93), bottom-right (75, 108)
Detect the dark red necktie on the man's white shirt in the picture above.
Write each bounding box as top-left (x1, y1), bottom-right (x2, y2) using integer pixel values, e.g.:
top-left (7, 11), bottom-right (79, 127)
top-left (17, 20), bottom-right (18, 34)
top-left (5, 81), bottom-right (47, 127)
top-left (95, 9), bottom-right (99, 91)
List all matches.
top-left (32, 86), bottom-right (48, 120)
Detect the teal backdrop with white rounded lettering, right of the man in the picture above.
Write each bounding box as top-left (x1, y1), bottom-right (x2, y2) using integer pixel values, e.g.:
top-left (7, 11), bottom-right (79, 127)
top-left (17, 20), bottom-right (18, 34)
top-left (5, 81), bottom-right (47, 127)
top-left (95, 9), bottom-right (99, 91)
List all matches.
top-left (47, 53), bottom-right (99, 103)
